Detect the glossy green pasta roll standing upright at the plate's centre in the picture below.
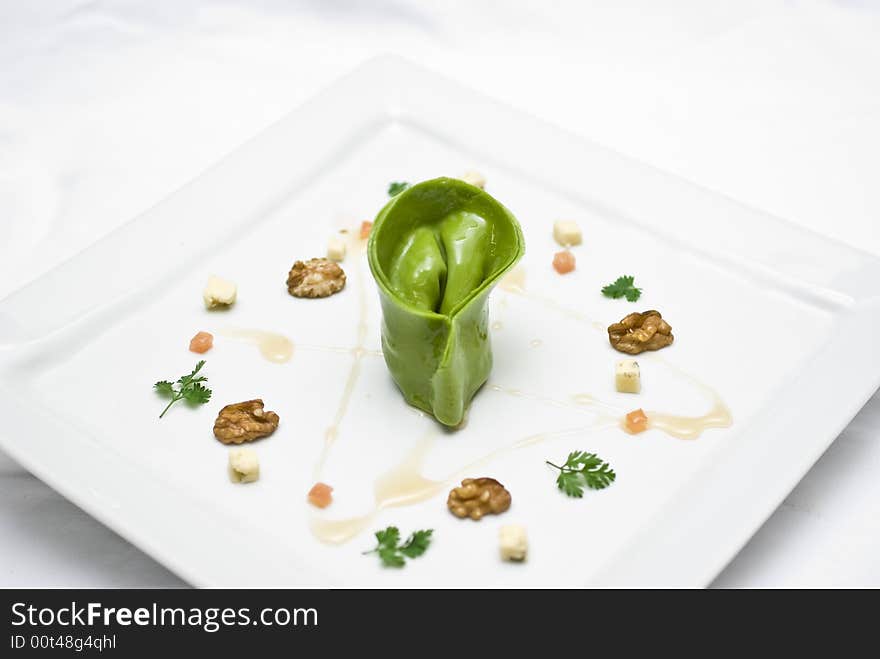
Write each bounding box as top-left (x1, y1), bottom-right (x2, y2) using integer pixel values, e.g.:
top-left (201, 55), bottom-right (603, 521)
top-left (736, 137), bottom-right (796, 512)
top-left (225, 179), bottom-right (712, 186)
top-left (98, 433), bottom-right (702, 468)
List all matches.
top-left (367, 178), bottom-right (525, 426)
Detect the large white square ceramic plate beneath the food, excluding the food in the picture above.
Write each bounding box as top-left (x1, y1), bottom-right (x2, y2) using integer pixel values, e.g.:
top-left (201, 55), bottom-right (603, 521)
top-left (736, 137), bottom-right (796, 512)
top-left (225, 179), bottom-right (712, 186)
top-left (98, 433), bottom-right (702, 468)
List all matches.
top-left (0, 58), bottom-right (880, 586)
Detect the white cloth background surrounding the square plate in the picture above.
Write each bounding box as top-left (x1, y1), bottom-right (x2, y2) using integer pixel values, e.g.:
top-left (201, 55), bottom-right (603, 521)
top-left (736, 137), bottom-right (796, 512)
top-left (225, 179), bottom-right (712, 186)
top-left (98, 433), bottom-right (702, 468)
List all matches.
top-left (0, 0), bottom-right (880, 587)
